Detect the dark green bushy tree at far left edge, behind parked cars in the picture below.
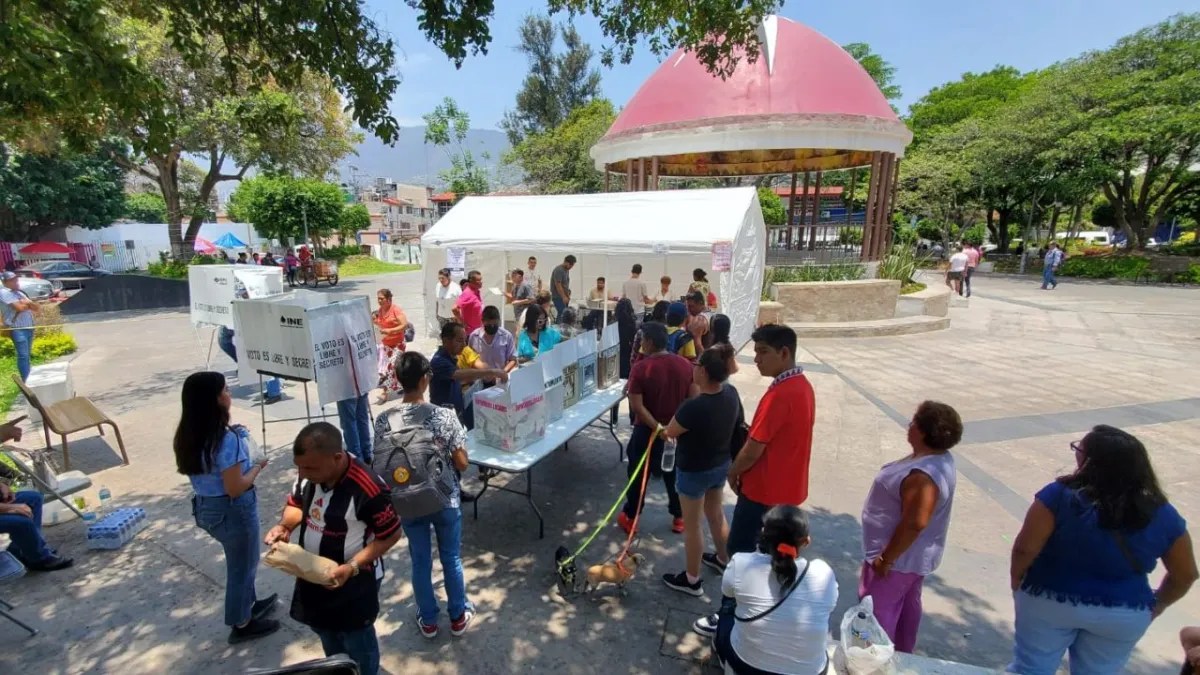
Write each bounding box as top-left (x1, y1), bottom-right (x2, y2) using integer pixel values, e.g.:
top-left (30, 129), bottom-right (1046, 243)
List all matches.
top-left (0, 144), bottom-right (125, 241)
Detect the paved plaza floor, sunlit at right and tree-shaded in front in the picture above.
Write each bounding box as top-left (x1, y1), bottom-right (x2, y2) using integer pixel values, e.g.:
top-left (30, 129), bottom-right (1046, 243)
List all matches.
top-left (0, 273), bottom-right (1200, 675)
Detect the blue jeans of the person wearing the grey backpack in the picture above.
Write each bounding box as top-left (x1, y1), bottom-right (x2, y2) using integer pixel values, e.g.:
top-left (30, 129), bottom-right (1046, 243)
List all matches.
top-left (402, 508), bottom-right (467, 625)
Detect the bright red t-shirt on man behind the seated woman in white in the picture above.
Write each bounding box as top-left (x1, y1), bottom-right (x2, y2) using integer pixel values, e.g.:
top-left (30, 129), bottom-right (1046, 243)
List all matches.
top-left (742, 370), bottom-right (816, 506)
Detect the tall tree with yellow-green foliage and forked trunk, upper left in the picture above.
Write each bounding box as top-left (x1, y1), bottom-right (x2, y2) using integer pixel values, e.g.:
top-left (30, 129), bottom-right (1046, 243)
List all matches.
top-left (109, 22), bottom-right (358, 258)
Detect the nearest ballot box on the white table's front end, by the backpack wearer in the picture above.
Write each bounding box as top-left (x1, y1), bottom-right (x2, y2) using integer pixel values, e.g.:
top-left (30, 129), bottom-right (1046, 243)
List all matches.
top-left (474, 357), bottom-right (546, 453)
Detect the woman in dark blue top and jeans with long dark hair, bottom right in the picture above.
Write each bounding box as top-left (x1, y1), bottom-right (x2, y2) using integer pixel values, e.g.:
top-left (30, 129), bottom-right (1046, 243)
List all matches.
top-left (1008, 425), bottom-right (1196, 675)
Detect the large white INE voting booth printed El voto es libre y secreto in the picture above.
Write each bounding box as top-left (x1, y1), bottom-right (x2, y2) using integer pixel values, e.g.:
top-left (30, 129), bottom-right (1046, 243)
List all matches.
top-left (226, 291), bottom-right (377, 406)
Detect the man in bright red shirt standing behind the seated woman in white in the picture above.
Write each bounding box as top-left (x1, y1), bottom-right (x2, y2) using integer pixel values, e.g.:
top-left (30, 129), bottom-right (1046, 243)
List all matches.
top-left (692, 323), bottom-right (816, 635)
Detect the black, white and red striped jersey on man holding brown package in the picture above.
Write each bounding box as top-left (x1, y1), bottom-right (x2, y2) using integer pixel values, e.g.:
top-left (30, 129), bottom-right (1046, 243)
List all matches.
top-left (288, 458), bottom-right (400, 631)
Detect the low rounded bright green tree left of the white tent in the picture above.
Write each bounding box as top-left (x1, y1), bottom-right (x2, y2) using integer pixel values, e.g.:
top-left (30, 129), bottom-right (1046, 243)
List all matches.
top-left (229, 175), bottom-right (345, 241)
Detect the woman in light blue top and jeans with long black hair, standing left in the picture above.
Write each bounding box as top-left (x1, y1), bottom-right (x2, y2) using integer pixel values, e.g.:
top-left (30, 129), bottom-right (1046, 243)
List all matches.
top-left (175, 372), bottom-right (280, 644)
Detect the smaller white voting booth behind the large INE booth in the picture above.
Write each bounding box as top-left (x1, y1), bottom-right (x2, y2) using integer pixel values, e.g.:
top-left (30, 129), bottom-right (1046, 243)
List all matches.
top-left (187, 265), bottom-right (283, 328)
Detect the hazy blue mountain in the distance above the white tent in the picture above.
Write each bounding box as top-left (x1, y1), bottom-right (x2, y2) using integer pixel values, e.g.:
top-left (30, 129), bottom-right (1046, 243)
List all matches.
top-left (338, 126), bottom-right (521, 187)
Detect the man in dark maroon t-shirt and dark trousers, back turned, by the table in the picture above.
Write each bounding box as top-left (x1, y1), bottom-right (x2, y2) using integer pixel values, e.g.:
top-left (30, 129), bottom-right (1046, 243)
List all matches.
top-left (617, 322), bottom-right (692, 533)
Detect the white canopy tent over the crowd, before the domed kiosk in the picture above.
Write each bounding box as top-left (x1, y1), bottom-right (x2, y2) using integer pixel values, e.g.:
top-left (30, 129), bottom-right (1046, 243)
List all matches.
top-left (421, 187), bottom-right (766, 345)
